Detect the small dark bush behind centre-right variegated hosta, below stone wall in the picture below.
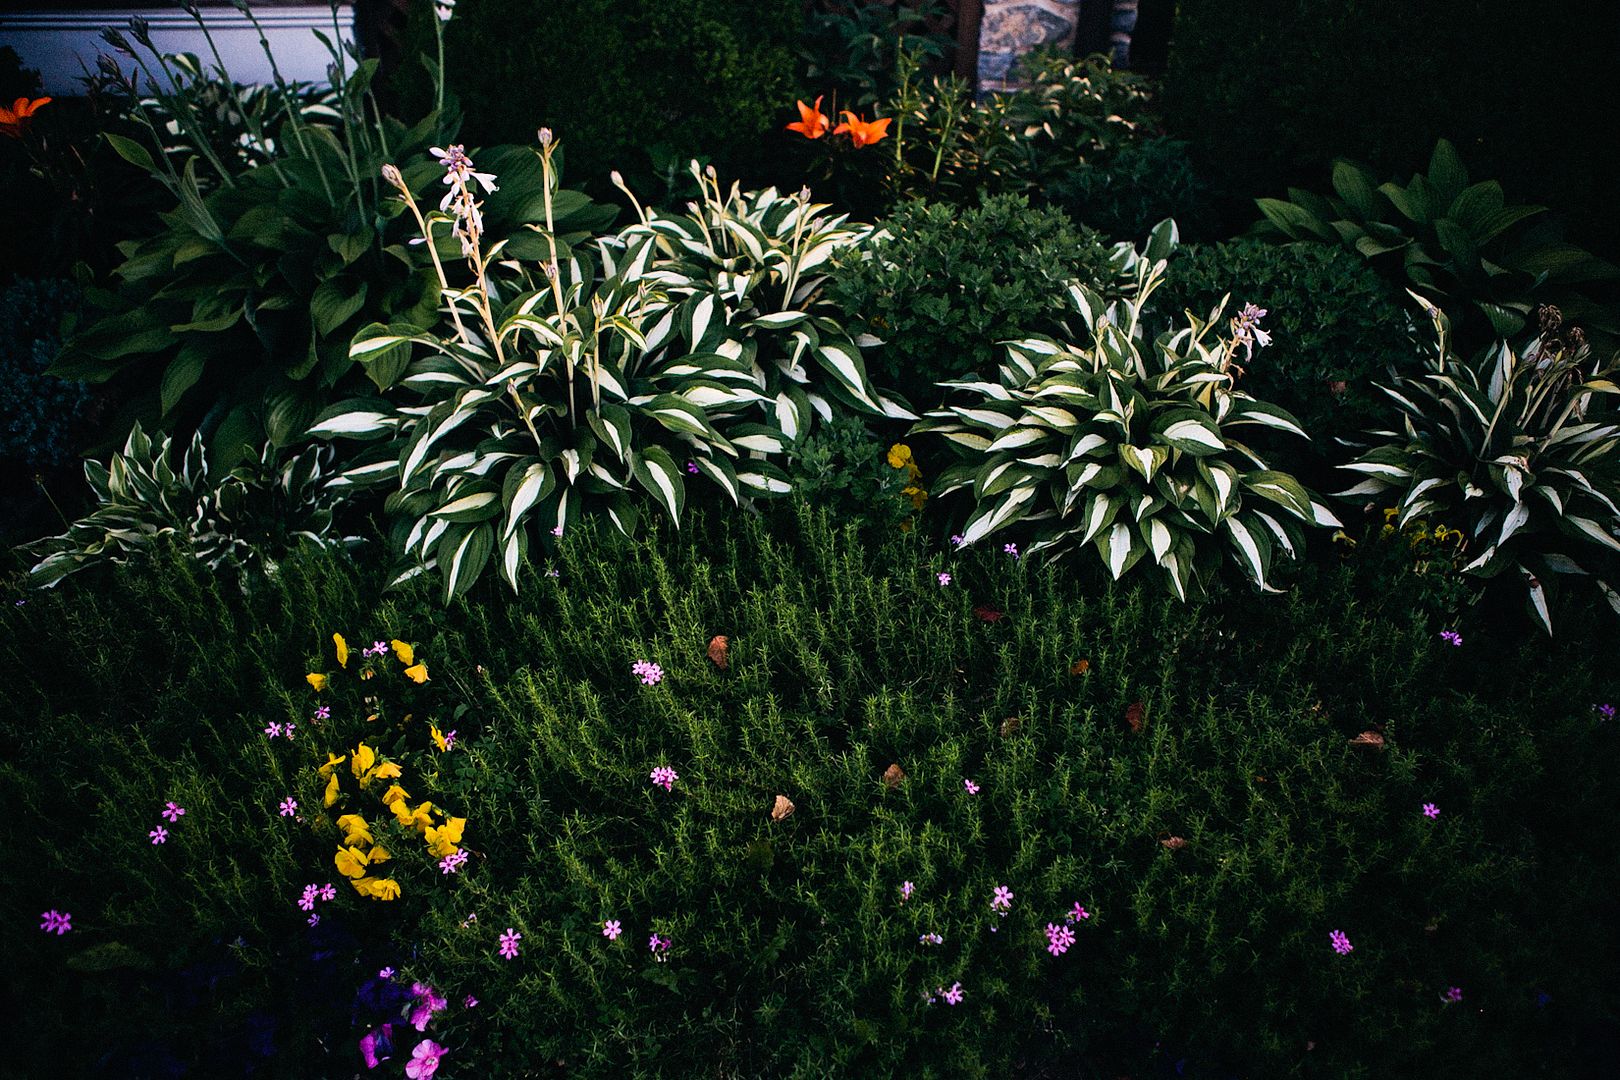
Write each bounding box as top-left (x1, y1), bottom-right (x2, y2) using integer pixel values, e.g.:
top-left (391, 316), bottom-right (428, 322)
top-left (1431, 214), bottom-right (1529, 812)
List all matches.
top-left (1043, 136), bottom-right (1210, 241)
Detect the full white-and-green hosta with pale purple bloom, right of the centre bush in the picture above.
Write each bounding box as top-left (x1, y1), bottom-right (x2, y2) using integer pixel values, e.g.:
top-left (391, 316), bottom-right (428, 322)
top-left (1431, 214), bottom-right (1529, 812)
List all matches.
top-left (915, 222), bottom-right (1338, 599)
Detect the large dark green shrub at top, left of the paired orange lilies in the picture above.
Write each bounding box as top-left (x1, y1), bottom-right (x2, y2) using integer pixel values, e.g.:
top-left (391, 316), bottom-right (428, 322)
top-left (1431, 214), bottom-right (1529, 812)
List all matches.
top-left (446, 0), bottom-right (804, 189)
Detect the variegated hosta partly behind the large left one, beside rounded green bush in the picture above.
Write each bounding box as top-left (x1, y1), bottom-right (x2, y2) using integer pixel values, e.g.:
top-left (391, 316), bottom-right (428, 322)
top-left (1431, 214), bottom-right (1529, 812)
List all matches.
top-left (608, 162), bottom-right (915, 440)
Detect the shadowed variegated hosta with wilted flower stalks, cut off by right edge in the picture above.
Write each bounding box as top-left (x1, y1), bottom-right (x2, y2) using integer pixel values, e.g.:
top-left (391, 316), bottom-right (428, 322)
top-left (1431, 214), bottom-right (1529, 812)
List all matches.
top-left (1343, 293), bottom-right (1620, 635)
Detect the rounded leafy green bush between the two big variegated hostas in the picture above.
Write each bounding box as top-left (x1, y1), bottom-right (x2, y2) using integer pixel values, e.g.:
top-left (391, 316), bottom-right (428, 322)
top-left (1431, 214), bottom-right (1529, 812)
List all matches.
top-left (829, 196), bottom-right (1111, 408)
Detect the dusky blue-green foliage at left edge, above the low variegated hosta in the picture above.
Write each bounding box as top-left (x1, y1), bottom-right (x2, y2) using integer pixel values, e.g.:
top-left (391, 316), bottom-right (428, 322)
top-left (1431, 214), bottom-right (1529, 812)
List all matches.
top-left (0, 279), bottom-right (89, 468)
